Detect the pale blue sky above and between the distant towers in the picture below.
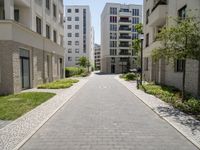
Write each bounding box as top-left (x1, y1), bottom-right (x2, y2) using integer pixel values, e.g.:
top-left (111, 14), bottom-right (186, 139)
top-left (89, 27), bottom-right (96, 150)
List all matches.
top-left (64, 0), bottom-right (143, 44)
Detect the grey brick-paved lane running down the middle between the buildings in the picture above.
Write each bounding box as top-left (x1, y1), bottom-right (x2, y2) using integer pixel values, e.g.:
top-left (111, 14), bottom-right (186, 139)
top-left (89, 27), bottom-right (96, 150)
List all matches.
top-left (21, 75), bottom-right (197, 150)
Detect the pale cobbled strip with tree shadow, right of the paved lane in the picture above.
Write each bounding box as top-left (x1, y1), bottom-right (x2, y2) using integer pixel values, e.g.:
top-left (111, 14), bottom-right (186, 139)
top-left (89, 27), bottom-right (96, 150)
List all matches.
top-left (115, 76), bottom-right (200, 149)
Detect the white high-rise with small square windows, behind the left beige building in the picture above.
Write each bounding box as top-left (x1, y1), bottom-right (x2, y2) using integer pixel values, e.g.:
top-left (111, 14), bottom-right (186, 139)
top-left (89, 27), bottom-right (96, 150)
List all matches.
top-left (64, 5), bottom-right (94, 67)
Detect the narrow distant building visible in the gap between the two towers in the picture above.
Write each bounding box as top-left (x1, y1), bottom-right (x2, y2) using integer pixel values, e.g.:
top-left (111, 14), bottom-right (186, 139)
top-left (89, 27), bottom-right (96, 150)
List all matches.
top-left (94, 44), bottom-right (101, 70)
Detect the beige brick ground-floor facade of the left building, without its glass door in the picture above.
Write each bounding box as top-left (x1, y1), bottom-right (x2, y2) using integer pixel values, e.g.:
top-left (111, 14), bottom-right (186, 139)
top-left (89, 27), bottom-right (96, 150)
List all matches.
top-left (0, 41), bottom-right (64, 94)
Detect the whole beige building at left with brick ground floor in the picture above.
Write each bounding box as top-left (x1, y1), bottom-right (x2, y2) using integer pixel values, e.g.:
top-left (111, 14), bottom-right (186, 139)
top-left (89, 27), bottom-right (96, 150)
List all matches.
top-left (0, 0), bottom-right (64, 94)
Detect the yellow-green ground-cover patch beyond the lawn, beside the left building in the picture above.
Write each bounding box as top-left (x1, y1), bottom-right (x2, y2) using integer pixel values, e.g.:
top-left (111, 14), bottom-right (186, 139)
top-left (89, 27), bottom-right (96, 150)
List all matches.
top-left (38, 79), bottom-right (79, 89)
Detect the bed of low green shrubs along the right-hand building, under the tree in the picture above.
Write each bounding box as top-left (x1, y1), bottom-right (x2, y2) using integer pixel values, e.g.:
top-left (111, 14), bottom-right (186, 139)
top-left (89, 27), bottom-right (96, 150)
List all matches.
top-left (140, 84), bottom-right (200, 120)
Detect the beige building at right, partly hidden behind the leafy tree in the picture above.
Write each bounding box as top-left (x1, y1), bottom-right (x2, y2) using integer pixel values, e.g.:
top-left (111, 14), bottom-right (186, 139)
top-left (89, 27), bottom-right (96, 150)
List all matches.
top-left (143, 0), bottom-right (200, 95)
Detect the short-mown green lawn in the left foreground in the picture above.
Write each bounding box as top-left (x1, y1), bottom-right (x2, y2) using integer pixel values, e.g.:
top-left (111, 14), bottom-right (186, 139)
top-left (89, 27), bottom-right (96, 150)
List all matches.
top-left (0, 92), bottom-right (55, 120)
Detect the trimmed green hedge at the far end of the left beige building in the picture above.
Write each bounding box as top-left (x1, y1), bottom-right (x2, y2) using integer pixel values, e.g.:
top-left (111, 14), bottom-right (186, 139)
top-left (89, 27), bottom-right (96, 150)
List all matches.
top-left (65, 67), bottom-right (85, 78)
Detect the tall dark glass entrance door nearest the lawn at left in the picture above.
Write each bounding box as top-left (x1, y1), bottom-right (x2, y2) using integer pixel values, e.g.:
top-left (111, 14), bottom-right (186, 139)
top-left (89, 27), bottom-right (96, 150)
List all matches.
top-left (20, 50), bottom-right (30, 89)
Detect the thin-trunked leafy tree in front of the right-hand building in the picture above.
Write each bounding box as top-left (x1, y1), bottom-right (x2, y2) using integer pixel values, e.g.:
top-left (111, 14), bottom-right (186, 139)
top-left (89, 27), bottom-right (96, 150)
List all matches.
top-left (152, 17), bottom-right (200, 101)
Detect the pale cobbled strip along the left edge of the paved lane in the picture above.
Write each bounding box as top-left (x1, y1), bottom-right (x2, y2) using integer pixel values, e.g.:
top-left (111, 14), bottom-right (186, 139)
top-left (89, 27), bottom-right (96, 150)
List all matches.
top-left (0, 79), bottom-right (88, 150)
